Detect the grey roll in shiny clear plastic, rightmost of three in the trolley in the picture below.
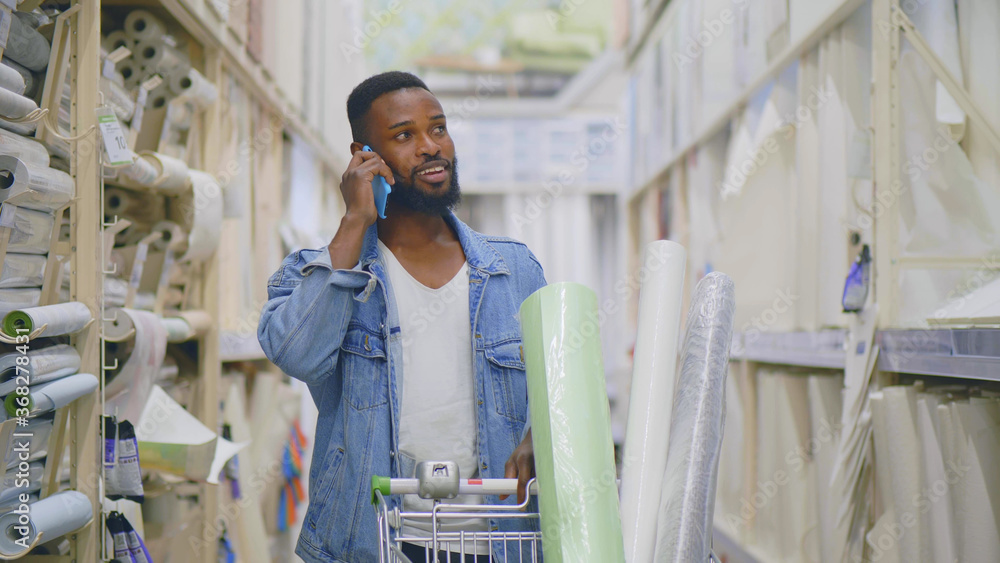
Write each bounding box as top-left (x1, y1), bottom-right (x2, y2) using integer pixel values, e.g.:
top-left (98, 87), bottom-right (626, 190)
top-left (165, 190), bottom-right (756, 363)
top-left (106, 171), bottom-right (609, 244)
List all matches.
top-left (653, 272), bottom-right (736, 563)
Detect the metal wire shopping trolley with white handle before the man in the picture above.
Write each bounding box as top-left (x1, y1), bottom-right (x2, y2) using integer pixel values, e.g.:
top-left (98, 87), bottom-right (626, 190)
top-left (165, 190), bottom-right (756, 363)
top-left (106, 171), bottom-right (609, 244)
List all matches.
top-left (372, 461), bottom-right (541, 563)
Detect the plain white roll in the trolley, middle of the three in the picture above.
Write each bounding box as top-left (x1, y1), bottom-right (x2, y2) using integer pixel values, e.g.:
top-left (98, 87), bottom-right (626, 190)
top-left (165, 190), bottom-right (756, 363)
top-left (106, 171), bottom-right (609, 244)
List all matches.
top-left (621, 240), bottom-right (687, 563)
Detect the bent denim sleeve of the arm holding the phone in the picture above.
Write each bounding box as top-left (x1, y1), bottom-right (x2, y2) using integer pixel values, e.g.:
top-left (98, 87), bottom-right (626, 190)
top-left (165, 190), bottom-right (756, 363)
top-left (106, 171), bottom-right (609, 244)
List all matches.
top-left (257, 248), bottom-right (376, 384)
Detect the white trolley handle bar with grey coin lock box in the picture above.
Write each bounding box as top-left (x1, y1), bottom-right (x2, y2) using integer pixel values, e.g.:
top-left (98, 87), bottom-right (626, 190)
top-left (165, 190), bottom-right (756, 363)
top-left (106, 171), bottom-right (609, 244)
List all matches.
top-left (372, 461), bottom-right (538, 504)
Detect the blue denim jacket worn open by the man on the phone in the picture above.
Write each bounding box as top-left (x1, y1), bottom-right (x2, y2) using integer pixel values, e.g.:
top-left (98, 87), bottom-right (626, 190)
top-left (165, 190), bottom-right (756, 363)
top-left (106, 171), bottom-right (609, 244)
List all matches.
top-left (257, 214), bottom-right (545, 563)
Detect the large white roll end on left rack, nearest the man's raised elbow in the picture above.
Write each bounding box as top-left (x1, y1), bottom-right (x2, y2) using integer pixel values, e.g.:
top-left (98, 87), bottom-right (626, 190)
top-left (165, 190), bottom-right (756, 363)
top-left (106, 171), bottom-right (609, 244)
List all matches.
top-left (179, 170), bottom-right (223, 262)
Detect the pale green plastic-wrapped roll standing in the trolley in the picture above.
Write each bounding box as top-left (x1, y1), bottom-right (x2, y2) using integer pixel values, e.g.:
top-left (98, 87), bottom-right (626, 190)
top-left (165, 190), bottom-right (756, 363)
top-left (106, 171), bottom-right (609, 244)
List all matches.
top-left (520, 283), bottom-right (625, 563)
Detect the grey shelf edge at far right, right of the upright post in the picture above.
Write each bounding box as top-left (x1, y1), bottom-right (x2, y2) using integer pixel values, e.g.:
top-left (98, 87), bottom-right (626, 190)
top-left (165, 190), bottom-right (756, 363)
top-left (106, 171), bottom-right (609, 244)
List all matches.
top-left (877, 328), bottom-right (1000, 381)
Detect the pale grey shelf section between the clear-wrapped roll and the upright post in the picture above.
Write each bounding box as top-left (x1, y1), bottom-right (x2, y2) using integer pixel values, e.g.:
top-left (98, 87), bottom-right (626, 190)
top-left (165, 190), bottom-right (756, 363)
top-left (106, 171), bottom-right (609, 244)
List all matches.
top-left (729, 330), bottom-right (847, 369)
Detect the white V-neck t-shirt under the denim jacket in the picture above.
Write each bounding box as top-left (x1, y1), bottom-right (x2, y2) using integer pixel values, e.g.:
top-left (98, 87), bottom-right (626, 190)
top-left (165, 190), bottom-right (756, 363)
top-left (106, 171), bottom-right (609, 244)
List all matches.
top-left (378, 241), bottom-right (488, 554)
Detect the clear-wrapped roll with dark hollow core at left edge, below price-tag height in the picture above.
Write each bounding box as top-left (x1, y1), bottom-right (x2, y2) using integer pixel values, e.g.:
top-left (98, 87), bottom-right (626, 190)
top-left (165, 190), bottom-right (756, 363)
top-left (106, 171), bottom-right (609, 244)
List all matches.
top-left (0, 155), bottom-right (76, 213)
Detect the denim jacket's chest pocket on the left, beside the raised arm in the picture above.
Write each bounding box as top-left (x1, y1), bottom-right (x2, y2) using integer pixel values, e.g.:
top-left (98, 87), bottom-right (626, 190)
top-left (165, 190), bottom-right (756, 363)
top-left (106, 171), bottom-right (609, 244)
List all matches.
top-left (339, 324), bottom-right (389, 410)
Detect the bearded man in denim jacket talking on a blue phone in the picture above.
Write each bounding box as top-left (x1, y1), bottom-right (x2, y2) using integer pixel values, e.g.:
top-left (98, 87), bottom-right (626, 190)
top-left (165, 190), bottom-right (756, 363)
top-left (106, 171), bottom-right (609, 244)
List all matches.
top-left (258, 72), bottom-right (545, 563)
